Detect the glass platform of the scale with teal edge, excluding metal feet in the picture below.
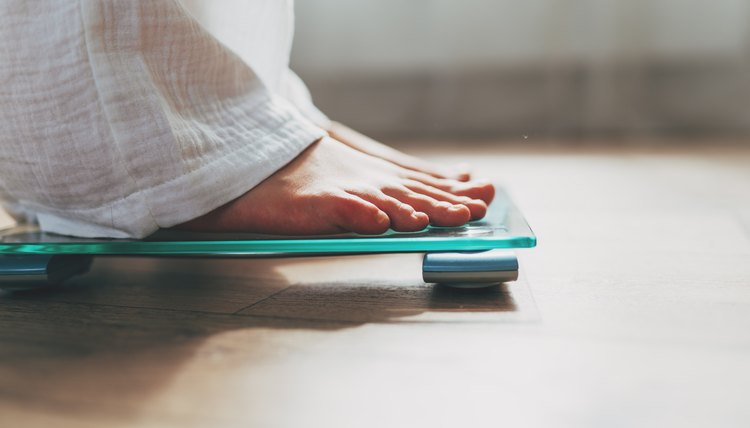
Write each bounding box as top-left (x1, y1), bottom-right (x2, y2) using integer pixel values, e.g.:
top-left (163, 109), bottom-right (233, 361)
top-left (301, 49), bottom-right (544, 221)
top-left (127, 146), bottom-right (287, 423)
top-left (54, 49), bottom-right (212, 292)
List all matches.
top-left (0, 188), bottom-right (537, 256)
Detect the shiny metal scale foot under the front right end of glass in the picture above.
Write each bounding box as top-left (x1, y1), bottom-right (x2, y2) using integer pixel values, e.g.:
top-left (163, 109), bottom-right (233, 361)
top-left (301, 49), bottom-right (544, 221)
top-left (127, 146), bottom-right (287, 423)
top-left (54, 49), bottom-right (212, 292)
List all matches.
top-left (422, 250), bottom-right (518, 288)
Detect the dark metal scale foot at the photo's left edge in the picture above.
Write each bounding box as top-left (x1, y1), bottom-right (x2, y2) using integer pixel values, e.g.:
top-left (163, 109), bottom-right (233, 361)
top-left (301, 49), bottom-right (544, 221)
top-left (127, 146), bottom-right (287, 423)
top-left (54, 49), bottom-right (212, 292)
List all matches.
top-left (0, 254), bottom-right (93, 291)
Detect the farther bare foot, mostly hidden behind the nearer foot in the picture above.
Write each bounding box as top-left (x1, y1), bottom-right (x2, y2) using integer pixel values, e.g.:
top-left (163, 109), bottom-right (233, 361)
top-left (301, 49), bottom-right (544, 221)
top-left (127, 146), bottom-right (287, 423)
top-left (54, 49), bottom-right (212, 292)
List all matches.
top-left (329, 122), bottom-right (472, 185)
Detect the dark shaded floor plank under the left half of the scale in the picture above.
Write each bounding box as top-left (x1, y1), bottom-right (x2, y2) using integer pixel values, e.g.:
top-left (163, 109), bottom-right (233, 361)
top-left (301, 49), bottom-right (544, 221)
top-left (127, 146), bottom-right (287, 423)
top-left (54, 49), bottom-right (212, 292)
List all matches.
top-left (7, 257), bottom-right (296, 313)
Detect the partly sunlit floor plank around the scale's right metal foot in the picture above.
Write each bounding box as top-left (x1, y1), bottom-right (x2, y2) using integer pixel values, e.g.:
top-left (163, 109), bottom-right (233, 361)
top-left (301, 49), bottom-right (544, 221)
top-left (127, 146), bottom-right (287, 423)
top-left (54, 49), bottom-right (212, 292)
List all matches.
top-left (239, 254), bottom-right (538, 323)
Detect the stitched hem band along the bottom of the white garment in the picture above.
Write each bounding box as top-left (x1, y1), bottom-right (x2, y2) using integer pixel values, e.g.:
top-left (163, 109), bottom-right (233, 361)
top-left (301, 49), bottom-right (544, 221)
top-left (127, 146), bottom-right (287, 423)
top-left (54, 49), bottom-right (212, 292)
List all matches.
top-left (33, 110), bottom-right (327, 238)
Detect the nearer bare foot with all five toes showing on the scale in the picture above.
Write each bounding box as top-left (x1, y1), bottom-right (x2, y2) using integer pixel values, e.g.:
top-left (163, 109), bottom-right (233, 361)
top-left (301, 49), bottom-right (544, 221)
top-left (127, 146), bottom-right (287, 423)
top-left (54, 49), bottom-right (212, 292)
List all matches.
top-left (178, 137), bottom-right (494, 235)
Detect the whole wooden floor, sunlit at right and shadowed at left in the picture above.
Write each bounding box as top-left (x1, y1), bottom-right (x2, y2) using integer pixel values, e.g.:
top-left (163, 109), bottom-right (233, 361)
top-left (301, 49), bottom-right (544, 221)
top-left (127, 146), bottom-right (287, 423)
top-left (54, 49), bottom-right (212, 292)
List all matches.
top-left (0, 143), bottom-right (750, 428)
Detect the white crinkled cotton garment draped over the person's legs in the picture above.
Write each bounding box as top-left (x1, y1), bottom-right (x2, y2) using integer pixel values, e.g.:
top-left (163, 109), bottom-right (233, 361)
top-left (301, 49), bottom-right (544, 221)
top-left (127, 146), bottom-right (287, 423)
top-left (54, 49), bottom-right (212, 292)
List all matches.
top-left (0, 0), bottom-right (327, 238)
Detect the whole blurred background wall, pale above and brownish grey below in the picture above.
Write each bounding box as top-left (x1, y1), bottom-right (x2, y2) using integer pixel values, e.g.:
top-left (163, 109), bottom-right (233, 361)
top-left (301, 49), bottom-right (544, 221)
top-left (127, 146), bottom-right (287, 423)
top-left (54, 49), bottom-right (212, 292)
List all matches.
top-left (292, 0), bottom-right (750, 136)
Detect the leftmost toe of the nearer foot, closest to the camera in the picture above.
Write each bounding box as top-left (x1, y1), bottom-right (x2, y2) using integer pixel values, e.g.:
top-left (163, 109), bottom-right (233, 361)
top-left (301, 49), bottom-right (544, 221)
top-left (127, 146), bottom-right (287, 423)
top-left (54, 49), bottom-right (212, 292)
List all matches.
top-left (330, 194), bottom-right (390, 235)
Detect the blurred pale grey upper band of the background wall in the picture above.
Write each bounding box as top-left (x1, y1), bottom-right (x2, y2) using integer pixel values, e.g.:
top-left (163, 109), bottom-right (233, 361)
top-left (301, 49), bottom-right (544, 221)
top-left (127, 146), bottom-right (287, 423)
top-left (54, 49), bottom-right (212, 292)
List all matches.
top-left (294, 0), bottom-right (750, 74)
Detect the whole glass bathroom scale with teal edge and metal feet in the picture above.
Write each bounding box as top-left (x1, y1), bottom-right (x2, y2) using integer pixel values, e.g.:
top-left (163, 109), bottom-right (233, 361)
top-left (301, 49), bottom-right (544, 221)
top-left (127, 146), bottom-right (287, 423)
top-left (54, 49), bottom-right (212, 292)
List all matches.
top-left (0, 189), bottom-right (536, 290)
